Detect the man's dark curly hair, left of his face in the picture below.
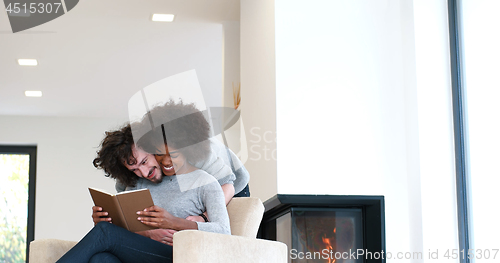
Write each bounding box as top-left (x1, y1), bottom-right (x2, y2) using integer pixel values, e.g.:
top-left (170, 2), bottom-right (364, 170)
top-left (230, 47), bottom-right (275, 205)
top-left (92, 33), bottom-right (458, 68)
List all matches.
top-left (93, 124), bottom-right (138, 186)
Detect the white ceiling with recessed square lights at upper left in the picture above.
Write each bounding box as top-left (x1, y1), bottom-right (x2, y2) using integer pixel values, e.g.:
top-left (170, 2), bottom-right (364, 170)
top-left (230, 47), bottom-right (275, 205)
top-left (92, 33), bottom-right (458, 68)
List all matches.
top-left (0, 0), bottom-right (240, 118)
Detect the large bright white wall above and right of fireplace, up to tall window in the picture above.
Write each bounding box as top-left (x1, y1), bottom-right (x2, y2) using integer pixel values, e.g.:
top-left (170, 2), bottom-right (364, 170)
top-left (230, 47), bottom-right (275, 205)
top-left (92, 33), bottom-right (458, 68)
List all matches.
top-left (270, 0), bottom-right (458, 262)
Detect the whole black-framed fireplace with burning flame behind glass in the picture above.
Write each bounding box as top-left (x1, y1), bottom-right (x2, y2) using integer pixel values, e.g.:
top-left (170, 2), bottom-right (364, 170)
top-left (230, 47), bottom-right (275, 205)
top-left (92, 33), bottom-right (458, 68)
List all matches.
top-left (258, 194), bottom-right (385, 263)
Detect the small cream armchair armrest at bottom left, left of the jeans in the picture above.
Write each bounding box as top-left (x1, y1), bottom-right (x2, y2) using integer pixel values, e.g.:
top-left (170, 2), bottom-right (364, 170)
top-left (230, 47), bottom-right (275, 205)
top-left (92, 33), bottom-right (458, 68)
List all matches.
top-left (30, 239), bottom-right (77, 263)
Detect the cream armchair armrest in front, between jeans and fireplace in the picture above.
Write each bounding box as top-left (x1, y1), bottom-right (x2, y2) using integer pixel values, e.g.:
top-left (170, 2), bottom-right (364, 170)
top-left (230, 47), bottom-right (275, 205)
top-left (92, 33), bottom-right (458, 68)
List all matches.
top-left (173, 230), bottom-right (288, 263)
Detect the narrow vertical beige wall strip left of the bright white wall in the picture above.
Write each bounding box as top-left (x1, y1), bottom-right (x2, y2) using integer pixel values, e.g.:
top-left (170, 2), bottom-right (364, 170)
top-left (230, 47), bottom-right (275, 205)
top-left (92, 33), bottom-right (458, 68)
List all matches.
top-left (240, 0), bottom-right (277, 201)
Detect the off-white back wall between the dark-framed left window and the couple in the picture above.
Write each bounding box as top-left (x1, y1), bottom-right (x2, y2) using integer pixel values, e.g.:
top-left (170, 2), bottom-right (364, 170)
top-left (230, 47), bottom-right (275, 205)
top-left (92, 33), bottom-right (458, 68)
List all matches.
top-left (0, 116), bottom-right (125, 241)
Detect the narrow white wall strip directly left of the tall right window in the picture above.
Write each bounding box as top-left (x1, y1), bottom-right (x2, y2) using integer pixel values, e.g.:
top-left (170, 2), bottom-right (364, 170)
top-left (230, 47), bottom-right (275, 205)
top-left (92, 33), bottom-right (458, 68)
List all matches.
top-left (413, 0), bottom-right (458, 262)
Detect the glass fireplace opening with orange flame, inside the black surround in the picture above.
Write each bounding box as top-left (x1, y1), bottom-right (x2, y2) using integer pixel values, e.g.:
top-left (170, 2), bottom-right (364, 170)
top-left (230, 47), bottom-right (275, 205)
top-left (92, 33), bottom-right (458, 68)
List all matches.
top-left (276, 208), bottom-right (363, 263)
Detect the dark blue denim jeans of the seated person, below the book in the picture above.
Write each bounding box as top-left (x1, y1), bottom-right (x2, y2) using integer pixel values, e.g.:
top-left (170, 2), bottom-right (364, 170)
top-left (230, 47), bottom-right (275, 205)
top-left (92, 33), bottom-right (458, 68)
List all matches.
top-left (57, 222), bottom-right (172, 263)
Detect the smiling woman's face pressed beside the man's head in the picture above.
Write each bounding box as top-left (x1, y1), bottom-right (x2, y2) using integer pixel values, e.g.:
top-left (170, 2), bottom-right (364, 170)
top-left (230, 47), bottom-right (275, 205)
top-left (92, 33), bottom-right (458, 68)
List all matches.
top-left (155, 145), bottom-right (189, 176)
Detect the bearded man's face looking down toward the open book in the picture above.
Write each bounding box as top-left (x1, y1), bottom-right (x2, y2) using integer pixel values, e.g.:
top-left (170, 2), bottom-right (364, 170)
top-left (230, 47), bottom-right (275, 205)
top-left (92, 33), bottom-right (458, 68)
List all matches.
top-left (124, 145), bottom-right (163, 183)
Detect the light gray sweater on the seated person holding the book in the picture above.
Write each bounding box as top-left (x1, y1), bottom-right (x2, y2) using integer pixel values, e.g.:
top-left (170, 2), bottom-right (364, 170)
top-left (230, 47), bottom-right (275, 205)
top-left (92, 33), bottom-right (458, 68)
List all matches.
top-left (121, 170), bottom-right (231, 234)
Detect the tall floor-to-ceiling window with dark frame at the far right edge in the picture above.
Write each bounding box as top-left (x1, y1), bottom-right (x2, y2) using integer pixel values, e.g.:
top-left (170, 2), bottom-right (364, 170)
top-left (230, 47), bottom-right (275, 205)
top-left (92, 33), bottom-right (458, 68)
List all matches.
top-left (448, 0), bottom-right (500, 262)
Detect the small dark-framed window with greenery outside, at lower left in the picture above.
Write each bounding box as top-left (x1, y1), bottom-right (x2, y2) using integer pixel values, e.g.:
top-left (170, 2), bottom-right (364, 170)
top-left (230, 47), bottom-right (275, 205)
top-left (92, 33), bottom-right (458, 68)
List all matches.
top-left (0, 146), bottom-right (36, 263)
